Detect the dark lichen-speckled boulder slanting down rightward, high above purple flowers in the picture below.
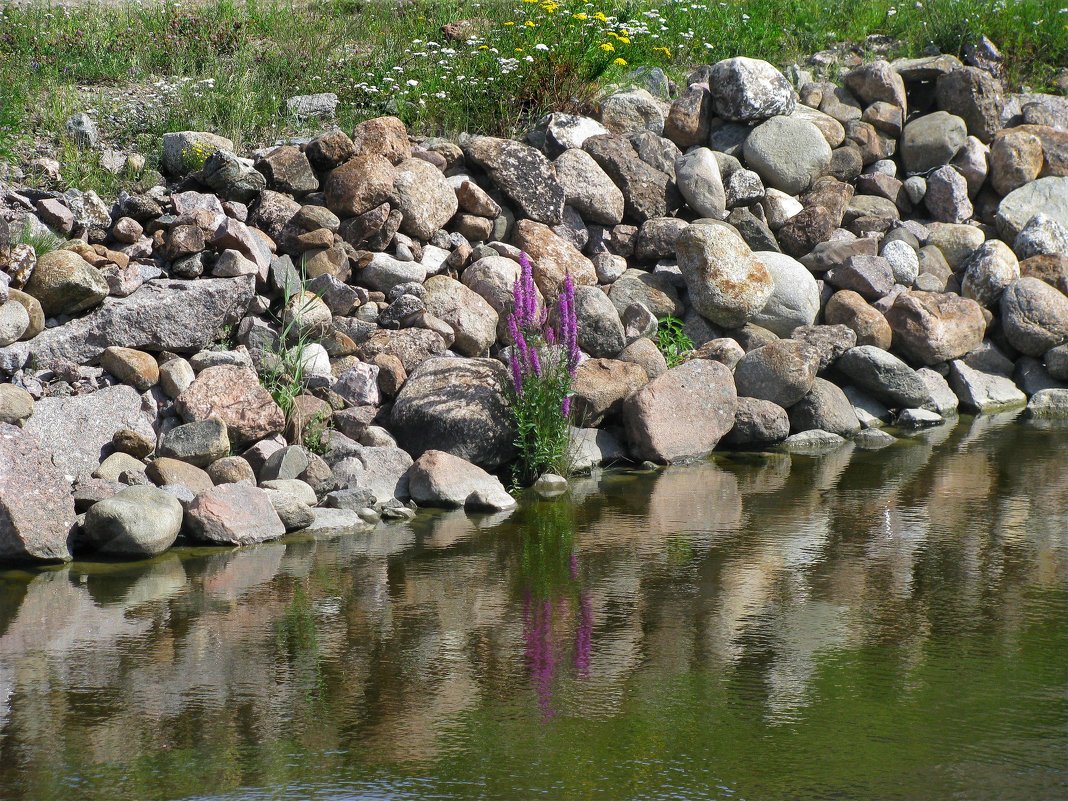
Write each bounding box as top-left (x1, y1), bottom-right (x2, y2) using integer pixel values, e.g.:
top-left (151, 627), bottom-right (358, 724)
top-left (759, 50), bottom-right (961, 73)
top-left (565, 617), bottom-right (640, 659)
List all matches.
top-left (462, 137), bottom-right (564, 225)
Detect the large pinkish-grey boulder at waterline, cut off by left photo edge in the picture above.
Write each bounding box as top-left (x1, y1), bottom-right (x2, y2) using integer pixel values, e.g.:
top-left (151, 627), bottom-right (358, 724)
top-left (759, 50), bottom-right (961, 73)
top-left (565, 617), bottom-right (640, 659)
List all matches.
top-left (0, 423), bottom-right (75, 563)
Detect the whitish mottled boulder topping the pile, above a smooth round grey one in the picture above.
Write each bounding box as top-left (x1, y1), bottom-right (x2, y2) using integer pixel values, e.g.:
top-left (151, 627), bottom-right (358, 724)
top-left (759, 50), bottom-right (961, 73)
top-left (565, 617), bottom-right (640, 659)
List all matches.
top-left (708, 57), bottom-right (797, 122)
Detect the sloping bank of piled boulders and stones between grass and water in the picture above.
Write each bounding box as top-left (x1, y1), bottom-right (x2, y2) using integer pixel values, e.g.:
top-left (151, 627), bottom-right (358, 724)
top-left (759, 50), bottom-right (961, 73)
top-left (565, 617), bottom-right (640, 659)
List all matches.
top-left (0, 56), bottom-right (1068, 562)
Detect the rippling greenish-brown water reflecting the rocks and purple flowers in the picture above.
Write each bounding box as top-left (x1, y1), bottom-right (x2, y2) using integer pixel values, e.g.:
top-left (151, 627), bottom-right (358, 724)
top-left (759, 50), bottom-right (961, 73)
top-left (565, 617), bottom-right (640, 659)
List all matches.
top-left (0, 417), bottom-right (1068, 801)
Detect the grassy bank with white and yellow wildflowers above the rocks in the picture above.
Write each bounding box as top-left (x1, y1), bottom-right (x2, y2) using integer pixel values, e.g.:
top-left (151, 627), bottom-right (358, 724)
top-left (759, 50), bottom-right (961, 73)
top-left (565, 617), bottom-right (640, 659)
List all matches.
top-left (0, 0), bottom-right (1068, 190)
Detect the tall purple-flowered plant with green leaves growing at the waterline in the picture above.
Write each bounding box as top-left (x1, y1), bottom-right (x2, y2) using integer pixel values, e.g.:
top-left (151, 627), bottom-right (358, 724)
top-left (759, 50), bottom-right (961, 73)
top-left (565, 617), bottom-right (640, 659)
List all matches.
top-left (508, 253), bottom-right (579, 485)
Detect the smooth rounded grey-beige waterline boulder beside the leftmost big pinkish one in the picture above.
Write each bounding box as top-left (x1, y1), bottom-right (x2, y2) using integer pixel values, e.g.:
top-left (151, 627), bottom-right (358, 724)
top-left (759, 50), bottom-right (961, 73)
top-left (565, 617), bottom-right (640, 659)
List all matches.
top-left (82, 487), bottom-right (184, 559)
